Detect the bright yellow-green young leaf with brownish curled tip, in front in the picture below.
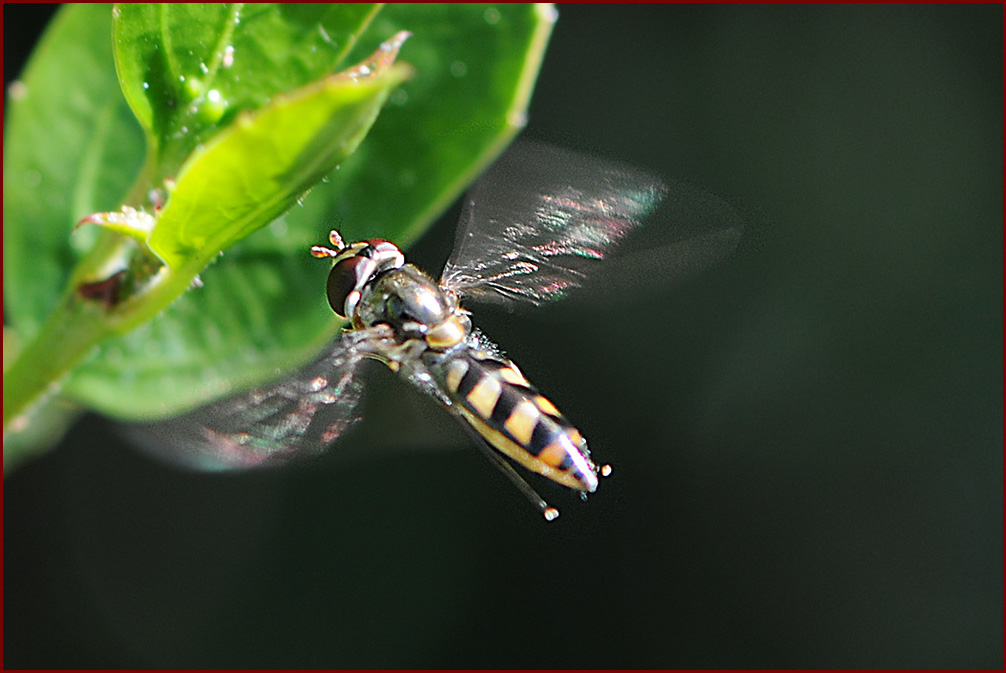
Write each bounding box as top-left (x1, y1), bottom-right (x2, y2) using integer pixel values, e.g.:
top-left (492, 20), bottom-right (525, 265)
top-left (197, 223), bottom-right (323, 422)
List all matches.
top-left (147, 34), bottom-right (408, 267)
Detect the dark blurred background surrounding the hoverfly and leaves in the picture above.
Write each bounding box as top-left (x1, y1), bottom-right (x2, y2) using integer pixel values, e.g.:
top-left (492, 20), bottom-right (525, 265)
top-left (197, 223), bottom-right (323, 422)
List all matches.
top-left (3, 4), bottom-right (1003, 668)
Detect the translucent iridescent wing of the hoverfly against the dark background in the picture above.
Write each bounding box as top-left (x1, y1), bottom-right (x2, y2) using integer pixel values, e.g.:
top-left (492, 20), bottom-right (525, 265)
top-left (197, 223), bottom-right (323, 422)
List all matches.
top-left (441, 141), bottom-right (740, 306)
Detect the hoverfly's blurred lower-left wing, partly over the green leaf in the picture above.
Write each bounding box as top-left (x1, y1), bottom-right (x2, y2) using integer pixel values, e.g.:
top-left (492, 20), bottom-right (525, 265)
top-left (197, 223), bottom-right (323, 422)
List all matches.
top-left (126, 338), bottom-right (363, 470)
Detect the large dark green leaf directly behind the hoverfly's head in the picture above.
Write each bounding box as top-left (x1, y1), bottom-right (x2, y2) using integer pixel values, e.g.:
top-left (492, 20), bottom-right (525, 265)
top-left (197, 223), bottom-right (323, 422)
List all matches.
top-left (69, 5), bottom-right (553, 417)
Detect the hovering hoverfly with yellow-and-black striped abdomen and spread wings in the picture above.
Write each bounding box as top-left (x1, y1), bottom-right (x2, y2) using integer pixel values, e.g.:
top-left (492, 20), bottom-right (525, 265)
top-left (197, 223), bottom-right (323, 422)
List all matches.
top-left (137, 141), bottom-right (739, 520)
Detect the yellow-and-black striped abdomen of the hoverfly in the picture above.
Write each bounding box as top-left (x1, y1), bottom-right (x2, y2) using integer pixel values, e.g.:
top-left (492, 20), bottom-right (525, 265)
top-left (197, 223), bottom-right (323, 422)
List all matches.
top-left (431, 348), bottom-right (598, 492)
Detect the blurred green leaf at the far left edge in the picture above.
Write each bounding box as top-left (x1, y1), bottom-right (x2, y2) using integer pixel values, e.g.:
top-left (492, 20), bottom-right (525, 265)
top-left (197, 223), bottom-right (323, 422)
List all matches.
top-left (3, 4), bottom-right (144, 342)
